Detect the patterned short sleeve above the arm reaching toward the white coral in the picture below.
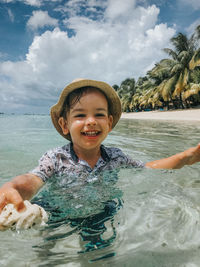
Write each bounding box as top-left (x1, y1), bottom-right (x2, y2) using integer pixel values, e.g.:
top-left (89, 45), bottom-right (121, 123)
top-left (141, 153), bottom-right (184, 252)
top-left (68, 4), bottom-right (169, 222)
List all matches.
top-left (29, 152), bottom-right (55, 182)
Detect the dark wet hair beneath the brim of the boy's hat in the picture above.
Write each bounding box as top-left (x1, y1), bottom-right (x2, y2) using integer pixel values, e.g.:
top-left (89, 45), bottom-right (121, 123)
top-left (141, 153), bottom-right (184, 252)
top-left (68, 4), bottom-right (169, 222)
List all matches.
top-left (60, 86), bottom-right (111, 118)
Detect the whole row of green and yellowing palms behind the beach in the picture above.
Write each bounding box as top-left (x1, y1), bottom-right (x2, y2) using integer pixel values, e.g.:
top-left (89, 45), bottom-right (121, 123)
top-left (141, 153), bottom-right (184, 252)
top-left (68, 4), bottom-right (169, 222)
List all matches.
top-left (114, 25), bottom-right (200, 112)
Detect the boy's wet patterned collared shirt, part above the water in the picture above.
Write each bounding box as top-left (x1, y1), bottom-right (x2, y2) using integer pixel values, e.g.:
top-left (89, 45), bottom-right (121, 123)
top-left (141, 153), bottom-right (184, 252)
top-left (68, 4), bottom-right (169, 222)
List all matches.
top-left (30, 143), bottom-right (145, 182)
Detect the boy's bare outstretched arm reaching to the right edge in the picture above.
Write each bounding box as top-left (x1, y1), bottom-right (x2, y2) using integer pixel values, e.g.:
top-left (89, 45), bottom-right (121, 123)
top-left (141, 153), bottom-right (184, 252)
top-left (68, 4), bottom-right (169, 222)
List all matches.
top-left (145, 143), bottom-right (200, 169)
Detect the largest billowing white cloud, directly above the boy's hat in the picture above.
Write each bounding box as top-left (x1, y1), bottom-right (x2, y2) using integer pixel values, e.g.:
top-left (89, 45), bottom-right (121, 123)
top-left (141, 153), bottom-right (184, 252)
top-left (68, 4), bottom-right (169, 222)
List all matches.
top-left (0, 0), bottom-right (175, 112)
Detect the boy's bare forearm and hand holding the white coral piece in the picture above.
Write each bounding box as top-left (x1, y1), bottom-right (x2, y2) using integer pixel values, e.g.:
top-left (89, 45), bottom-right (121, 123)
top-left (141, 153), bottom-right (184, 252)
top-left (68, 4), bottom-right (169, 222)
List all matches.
top-left (0, 176), bottom-right (44, 213)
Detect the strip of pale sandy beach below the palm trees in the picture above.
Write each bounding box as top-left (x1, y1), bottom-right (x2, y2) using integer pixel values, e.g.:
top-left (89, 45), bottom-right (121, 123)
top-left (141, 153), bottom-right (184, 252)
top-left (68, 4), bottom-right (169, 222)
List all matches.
top-left (122, 109), bottom-right (200, 122)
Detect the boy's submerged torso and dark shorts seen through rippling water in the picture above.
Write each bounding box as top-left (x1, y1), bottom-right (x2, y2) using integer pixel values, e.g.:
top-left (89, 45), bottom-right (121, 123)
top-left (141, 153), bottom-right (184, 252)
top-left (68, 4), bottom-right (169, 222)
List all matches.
top-left (32, 170), bottom-right (122, 258)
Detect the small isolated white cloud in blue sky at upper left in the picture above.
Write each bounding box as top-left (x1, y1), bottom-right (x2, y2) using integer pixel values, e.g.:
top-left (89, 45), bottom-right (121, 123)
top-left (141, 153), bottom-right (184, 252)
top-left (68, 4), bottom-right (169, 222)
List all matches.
top-left (27, 10), bottom-right (58, 30)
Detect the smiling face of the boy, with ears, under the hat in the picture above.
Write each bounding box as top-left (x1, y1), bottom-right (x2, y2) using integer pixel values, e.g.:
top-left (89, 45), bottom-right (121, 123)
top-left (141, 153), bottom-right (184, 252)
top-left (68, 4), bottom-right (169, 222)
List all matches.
top-left (59, 89), bottom-right (113, 152)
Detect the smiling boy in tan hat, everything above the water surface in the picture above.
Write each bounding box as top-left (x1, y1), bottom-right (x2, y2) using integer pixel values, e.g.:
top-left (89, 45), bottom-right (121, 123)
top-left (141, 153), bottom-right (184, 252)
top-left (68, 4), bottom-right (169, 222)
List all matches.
top-left (0, 79), bottom-right (200, 212)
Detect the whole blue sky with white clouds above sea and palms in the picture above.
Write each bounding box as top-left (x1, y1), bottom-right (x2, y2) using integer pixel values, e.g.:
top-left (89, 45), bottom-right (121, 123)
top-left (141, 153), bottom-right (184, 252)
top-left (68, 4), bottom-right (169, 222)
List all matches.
top-left (0, 0), bottom-right (200, 113)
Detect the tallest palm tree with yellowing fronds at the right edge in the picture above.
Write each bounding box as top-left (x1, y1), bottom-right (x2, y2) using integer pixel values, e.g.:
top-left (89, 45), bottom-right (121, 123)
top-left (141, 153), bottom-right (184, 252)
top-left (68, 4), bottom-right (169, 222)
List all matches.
top-left (148, 25), bottom-right (200, 108)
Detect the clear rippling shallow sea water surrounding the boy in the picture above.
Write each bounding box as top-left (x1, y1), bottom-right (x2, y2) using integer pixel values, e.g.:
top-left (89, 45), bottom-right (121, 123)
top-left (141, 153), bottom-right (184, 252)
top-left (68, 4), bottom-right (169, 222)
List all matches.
top-left (0, 115), bottom-right (200, 267)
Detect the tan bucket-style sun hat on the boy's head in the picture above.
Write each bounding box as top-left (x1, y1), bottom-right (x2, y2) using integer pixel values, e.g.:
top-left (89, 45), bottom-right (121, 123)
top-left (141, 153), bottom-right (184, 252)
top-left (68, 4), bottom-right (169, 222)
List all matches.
top-left (51, 78), bottom-right (122, 141)
